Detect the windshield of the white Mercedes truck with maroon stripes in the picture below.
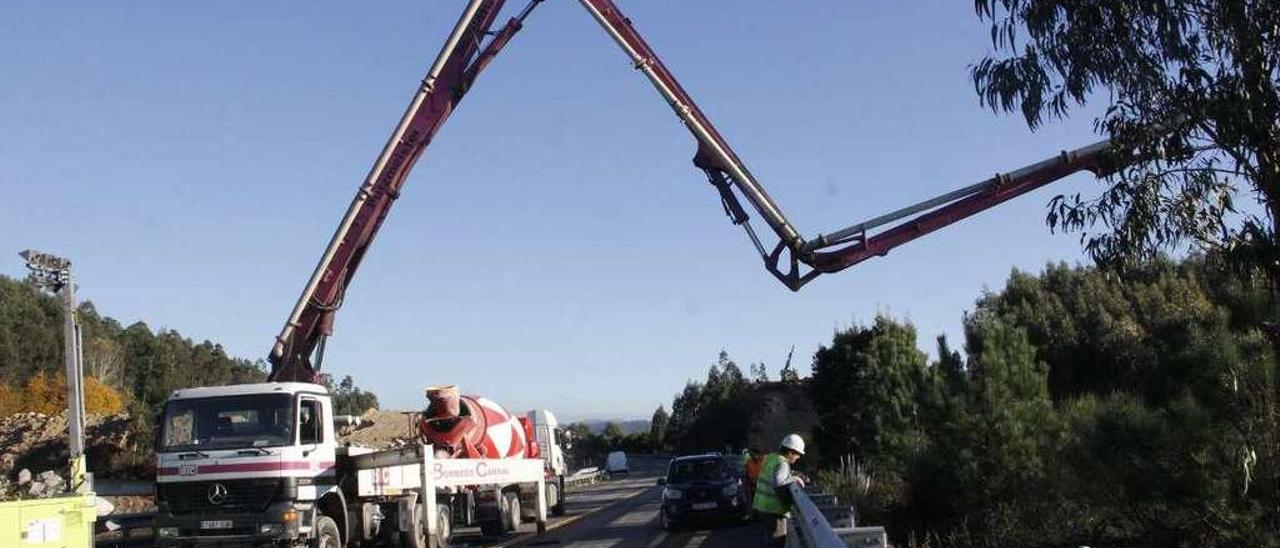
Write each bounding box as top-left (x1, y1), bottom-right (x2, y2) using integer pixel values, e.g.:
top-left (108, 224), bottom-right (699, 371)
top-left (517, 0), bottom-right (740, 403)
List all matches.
top-left (161, 394), bottom-right (293, 451)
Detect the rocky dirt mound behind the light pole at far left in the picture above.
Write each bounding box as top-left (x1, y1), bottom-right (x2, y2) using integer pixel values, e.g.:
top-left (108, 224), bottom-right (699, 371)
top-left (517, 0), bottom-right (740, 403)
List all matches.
top-left (0, 412), bottom-right (151, 480)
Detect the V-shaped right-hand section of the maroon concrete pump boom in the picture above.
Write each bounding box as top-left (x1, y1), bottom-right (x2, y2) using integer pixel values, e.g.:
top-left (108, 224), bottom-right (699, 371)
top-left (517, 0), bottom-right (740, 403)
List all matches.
top-left (579, 0), bottom-right (1117, 291)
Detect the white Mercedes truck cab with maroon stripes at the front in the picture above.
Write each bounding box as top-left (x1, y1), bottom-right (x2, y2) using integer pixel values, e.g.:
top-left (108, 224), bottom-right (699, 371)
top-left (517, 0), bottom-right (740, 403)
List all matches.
top-left (156, 383), bottom-right (346, 545)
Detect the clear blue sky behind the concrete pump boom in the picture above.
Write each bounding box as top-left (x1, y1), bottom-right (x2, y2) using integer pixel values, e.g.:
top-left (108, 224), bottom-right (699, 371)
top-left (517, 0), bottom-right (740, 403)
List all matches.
top-left (0, 0), bottom-right (1098, 417)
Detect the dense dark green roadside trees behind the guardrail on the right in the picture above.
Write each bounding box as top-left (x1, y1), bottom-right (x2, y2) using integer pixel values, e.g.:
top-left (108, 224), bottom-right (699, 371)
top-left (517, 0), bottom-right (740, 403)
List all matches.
top-left (650, 256), bottom-right (1280, 547)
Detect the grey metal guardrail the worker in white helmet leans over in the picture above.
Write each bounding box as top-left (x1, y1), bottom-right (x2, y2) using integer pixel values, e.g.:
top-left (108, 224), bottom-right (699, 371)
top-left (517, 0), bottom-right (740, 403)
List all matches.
top-left (787, 484), bottom-right (888, 548)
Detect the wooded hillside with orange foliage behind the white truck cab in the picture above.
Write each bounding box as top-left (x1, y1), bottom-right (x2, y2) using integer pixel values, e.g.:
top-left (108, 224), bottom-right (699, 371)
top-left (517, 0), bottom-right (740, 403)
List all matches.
top-left (0, 275), bottom-right (378, 476)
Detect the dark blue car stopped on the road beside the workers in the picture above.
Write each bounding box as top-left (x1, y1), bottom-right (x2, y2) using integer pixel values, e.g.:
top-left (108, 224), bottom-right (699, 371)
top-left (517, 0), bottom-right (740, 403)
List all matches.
top-left (658, 453), bottom-right (751, 531)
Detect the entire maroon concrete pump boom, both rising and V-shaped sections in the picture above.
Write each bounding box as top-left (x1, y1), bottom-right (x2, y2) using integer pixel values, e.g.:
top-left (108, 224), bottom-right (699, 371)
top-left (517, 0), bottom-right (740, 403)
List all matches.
top-left (268, 0), bottom-right (1131, 383)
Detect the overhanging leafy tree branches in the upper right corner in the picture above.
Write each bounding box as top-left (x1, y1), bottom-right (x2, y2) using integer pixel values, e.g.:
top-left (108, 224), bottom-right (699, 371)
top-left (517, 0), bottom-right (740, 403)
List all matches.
top-left (973, 0), bottom-right (1280, 282)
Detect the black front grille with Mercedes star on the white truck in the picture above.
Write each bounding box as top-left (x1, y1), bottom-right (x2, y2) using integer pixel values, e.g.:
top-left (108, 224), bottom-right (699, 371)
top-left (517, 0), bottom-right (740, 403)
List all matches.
top-left (156, 478), bottom-right (284, 515)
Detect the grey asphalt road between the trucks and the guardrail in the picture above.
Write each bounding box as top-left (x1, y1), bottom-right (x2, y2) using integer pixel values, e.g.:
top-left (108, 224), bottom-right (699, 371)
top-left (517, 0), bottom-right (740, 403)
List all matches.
top-left (453, 458), bottom-right (759, 548)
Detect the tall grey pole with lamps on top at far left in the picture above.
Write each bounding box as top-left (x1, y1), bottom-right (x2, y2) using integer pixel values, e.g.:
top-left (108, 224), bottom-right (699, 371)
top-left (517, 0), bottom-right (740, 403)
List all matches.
top-left (18, 250), bottom-right (93, 493)
